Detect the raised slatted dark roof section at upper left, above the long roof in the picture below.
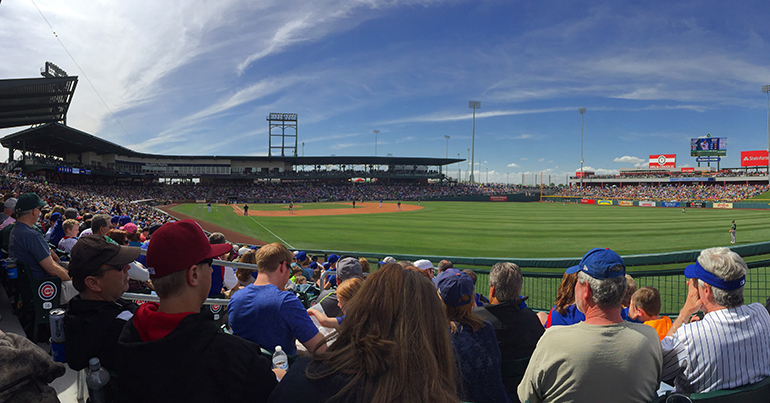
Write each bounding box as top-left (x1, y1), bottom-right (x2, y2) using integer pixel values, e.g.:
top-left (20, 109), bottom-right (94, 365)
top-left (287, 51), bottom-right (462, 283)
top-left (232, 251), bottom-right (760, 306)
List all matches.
top-left (0, 76), bottom-right (78, 129)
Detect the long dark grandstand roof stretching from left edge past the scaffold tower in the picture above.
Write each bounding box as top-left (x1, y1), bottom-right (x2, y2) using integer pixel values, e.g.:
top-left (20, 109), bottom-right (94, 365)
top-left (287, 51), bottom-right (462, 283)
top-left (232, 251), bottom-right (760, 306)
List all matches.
top-left (0, 122), bottom-right (464, 166)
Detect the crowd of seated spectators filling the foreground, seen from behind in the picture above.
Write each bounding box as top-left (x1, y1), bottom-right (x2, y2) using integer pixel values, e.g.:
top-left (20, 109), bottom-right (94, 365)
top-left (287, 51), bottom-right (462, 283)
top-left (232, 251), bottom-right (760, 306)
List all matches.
top-left (0, 171), bottom-right (770, 402)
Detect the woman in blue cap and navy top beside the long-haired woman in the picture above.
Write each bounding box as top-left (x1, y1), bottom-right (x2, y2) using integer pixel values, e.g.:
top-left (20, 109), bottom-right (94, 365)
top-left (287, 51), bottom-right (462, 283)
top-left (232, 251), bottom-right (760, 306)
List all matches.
top-left (436, 269), bottom-right (513, 403)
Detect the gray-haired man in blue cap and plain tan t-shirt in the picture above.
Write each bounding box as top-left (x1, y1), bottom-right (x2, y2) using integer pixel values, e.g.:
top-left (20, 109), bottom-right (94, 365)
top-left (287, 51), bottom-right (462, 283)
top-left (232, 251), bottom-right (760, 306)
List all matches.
top-left (517, 248), bottom-right (663, 403)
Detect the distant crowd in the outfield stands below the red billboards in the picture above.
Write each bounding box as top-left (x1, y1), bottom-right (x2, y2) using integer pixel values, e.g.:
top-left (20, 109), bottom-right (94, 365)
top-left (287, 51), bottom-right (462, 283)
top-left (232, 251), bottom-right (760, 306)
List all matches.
top-left (555, 184), bottom-right (770, 201)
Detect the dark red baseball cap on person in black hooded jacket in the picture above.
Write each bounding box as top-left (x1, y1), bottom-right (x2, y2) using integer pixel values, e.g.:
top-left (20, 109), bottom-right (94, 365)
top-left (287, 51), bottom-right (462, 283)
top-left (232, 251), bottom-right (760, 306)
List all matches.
top-left (147, 220), bottom-right (232, 278)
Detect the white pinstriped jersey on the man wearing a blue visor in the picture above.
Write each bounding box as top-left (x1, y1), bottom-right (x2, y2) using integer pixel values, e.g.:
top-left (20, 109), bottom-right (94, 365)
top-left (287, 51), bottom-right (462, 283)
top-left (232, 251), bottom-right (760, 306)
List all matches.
top-left (662, 303), bottom-right (770, 393)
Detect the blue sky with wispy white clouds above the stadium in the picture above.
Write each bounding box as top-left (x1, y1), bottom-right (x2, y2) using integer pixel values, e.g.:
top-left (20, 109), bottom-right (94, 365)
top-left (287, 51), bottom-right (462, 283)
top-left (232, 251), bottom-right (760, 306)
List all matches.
top-left (0, 0), bottom-right (770, 184)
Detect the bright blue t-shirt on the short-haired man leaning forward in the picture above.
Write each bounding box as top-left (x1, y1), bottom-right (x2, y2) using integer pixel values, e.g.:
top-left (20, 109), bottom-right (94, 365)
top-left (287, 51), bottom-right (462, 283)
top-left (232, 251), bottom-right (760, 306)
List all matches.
top-left (227, 284), bottom-right (318, 355)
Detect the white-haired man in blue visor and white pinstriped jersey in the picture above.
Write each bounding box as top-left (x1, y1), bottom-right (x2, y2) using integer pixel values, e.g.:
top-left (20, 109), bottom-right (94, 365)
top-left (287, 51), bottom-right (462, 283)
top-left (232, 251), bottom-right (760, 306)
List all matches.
top-left (662, 248), bottom-right (770, 393)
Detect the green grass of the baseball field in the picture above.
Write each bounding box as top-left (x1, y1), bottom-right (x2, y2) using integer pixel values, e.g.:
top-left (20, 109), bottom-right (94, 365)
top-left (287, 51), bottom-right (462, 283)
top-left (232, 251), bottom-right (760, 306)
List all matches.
top-left (174, 202), bottom-right (770, 258)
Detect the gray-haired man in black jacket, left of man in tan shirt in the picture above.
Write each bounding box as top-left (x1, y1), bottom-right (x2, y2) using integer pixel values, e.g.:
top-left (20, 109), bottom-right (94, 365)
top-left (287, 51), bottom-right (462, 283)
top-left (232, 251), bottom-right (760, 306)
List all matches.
top-left (472, 261), bottom-right (545, 396)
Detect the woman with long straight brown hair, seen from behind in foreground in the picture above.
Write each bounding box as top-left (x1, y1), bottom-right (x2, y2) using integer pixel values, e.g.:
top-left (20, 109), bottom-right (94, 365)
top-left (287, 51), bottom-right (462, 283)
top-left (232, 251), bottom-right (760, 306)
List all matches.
top-left (269, 264), bottom-right (459, 403)
